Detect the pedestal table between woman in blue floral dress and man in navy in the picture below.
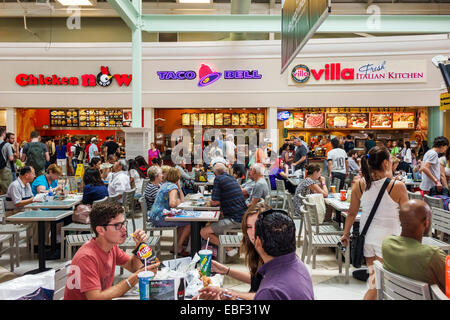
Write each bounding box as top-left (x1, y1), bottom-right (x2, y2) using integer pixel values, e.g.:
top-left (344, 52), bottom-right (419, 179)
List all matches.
top-left (165, 211), bottom-right (220, 257)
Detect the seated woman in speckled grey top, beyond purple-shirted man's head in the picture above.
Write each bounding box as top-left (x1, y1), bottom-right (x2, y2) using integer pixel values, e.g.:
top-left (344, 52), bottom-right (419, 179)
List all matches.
top-left (293, 164), bottom-right (328, 215)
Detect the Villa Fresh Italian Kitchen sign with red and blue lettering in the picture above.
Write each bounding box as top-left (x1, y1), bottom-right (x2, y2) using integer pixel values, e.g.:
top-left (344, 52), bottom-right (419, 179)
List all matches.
top-left (288, 59), bottom-right (427, 86)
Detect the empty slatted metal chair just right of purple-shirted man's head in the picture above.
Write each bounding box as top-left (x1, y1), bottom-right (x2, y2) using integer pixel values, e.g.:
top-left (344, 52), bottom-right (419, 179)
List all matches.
top-left (300, 206), bottom-right (350, 283)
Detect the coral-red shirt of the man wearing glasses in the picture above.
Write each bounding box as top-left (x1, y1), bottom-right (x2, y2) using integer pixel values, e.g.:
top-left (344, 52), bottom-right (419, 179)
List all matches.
top-left (64, 239), bottom-right (130, 300)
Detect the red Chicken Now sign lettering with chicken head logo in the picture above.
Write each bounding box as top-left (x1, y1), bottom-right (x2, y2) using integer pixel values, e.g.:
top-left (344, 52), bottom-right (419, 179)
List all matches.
top-left (16, 66), bottom-right (132, 87)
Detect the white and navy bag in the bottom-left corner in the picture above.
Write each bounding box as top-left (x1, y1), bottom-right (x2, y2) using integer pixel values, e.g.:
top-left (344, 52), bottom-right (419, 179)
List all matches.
top-left (0, 269), bottom-right (55, 300)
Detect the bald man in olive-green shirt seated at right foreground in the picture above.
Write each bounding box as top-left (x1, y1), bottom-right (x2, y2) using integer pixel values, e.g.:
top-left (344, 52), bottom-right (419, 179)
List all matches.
top-left (382, 200), bottom-right (446, 292)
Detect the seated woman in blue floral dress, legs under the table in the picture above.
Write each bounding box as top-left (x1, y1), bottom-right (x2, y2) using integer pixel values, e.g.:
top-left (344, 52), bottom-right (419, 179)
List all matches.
top-left (149, 168), bottom-right (191, 257)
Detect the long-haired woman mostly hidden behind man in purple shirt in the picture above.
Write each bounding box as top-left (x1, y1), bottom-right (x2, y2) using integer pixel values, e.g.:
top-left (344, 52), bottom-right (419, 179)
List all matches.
top-left (195, 202), bottom-right (270, 300)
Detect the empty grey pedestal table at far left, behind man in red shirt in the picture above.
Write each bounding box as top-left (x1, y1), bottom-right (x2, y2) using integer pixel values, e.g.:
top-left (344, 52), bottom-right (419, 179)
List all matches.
top-left (6, 210), bottom-right (73, 274)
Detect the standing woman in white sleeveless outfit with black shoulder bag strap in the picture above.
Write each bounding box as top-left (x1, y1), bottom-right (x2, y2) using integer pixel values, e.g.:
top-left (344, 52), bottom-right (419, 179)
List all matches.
top-left (341, 147), bottom-right (408, 300)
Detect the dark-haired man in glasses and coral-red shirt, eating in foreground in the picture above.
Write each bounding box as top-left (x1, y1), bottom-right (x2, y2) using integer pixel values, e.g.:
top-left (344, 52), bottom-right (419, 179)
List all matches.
top-left (64, 202), bottom-right (159, 300)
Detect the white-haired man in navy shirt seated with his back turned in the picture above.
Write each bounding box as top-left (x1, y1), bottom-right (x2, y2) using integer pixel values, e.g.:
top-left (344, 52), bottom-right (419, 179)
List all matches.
top-left (200, 163), bottom-right (247, 257)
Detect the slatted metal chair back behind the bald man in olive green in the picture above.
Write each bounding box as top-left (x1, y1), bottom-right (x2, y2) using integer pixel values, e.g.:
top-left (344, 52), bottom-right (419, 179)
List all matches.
top-left (373, 260), bottom-right (431, 300)
